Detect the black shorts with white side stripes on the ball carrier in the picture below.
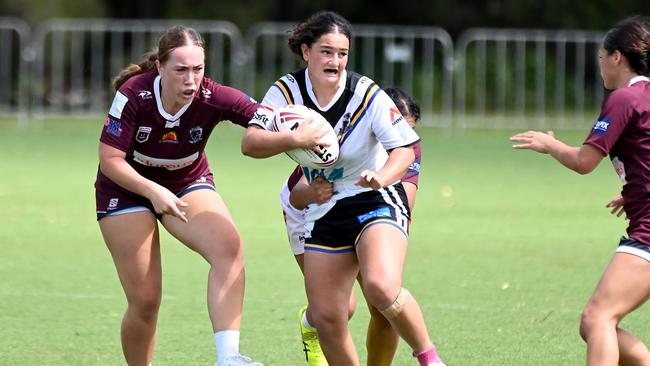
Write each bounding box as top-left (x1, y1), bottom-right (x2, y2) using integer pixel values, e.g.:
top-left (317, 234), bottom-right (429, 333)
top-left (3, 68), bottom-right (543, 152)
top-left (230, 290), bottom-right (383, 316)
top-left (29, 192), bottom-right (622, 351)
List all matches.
top-left (305, 183), bottom-right (411, 253)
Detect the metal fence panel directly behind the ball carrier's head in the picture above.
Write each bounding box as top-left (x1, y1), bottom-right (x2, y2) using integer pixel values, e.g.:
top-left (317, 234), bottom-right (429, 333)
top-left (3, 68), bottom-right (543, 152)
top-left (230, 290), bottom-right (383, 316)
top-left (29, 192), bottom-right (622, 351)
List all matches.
top-left (246, 23), bottom-right (454, 127)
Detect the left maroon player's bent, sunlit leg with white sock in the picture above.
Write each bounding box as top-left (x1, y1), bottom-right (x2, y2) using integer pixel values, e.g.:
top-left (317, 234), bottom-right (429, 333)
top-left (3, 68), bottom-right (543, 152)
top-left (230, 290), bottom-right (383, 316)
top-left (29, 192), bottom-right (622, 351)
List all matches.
top-left (162, 189), bottom-right (260, 365)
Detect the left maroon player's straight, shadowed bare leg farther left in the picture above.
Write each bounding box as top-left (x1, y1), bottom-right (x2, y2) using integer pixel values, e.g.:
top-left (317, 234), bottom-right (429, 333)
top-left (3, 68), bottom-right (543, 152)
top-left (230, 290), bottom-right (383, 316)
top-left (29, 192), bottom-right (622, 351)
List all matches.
top-left (99, 211), bottom-right (162, 366)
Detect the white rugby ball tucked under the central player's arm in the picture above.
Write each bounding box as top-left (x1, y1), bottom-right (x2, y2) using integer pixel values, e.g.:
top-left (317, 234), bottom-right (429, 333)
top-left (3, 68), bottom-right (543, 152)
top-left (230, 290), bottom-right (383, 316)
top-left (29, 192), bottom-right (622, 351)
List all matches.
top-left (273, 104), bottom-right (339, 168)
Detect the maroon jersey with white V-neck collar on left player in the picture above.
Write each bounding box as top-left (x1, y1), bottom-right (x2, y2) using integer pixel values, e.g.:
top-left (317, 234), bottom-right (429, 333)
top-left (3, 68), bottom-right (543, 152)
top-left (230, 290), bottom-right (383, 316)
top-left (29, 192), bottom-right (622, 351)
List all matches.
top-left (95, 71), bottom-right (258, 193)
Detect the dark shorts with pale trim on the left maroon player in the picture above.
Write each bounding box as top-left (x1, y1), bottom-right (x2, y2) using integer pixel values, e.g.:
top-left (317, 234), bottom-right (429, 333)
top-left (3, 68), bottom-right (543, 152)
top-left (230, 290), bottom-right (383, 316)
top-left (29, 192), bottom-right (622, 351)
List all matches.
top-left (95, 173), bottom-right (216, 220)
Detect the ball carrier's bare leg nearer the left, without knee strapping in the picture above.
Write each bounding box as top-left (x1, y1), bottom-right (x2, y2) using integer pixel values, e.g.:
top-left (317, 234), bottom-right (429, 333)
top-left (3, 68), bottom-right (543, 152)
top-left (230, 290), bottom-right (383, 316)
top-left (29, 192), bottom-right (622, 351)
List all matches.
top-left (305, 250), bottom-right (359, 366)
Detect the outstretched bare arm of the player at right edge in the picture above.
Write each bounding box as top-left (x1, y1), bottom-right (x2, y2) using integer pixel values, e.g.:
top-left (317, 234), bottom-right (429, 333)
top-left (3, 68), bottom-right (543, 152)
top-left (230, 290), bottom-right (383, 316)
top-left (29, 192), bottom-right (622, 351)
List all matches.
top-left (510, 131), bottom-right (605, 174)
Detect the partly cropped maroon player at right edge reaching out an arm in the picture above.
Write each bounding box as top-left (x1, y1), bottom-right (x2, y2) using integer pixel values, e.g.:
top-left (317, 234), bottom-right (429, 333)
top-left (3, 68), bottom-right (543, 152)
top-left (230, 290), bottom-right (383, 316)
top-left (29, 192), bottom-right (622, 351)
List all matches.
top-left (511, 16), bottom-right (650, 366)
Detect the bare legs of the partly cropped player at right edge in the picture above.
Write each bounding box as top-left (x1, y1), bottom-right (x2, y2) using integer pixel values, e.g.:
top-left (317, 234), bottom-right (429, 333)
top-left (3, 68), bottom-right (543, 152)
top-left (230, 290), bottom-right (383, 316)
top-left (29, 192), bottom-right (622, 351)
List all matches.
top-left (580, 253), bottom-right (650, 366)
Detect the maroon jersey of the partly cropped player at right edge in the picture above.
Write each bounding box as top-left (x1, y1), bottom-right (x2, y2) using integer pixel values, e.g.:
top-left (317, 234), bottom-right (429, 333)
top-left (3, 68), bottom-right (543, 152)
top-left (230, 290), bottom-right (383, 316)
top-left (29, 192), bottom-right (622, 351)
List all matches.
top-left (585, 77), bottom-right (650, 245)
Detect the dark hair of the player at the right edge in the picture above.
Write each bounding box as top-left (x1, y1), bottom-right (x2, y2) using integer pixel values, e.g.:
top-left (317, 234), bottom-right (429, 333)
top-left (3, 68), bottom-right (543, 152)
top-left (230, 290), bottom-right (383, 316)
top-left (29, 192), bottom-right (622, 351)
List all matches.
top-left (603, 15), bottom-right (650, 76)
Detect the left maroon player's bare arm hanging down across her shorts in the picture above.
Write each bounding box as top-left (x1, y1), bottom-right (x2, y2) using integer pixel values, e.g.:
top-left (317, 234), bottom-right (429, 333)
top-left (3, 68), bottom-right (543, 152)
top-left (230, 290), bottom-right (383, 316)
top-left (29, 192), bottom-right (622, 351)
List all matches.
top-left (99, 142), bottom-right (187, 222)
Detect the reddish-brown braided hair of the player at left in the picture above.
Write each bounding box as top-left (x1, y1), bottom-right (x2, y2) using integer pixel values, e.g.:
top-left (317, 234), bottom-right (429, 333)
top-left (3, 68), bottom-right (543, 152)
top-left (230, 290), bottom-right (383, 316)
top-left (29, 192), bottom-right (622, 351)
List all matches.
top-left (113, 25), bottom-right (204, 90)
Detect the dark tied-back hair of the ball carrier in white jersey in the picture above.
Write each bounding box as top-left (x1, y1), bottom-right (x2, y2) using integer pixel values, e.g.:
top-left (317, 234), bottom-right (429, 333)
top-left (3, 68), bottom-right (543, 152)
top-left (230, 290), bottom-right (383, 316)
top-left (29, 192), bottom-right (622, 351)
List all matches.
top-left (288, 11), bottom-right (352, 59)
